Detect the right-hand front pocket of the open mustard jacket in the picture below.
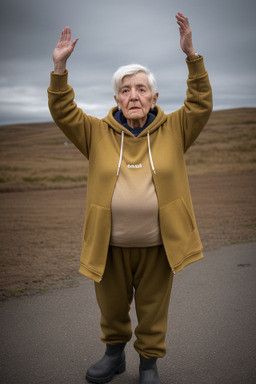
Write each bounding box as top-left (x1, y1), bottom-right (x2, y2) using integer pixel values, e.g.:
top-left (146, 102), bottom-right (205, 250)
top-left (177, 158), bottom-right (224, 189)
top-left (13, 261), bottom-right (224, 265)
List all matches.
top-left (159, 198), bottom-right (202, 267)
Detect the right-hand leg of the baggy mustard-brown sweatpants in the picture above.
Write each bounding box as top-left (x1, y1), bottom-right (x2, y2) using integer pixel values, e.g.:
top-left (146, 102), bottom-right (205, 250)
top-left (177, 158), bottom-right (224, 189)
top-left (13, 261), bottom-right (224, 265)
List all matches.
top-left (133, 246), bottom-right (173, 358)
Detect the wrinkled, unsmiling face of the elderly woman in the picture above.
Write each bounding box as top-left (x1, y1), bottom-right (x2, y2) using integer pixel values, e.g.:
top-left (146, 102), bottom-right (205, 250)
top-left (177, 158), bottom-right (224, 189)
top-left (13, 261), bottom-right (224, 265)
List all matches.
top-left (115, 72), bottom-right (158, 128)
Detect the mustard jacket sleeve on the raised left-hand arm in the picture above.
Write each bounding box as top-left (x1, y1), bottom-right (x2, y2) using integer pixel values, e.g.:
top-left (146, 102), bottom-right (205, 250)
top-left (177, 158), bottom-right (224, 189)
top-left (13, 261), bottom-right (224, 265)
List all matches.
top-left (48, 71), bottom-right (100, 159)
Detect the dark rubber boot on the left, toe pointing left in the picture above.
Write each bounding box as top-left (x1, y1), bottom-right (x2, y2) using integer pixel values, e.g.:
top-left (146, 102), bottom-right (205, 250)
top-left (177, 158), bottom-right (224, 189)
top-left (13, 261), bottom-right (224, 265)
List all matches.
top-left (85, 343), bottom-right (125, 383)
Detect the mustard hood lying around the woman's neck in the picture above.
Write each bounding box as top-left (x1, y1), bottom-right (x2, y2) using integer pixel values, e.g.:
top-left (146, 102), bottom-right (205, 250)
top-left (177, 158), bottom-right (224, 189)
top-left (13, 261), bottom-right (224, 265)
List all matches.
top-left (102, 106), bottom-right (167, 137)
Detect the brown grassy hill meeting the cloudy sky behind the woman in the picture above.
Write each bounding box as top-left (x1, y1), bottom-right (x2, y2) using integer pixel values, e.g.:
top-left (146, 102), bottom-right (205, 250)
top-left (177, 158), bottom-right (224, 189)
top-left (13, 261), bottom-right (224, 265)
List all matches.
top-left (0, 108), bottom-right (256, 192)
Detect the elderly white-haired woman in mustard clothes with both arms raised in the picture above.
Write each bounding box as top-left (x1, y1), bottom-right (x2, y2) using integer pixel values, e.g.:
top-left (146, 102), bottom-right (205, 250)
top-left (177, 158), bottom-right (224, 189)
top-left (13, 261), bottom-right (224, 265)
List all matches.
top-left (48, 13), bottom-right (212, 384)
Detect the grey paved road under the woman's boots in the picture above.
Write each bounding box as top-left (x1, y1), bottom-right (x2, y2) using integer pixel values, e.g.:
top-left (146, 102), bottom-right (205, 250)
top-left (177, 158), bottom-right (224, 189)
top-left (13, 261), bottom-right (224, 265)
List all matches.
top-left (0, 243), bottom-right (256, 384)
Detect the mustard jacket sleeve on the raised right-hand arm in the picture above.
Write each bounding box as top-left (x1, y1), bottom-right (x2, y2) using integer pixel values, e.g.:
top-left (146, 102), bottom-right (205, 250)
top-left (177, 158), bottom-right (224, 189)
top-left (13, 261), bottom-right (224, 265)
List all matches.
top-left (174, 56), bottom-right (212, 152)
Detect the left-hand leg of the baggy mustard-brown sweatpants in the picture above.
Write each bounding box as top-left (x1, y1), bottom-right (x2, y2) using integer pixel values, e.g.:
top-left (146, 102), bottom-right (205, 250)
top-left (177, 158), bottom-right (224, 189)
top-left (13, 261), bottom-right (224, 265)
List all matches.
top-left (95, 247), bottom-right (133, 345)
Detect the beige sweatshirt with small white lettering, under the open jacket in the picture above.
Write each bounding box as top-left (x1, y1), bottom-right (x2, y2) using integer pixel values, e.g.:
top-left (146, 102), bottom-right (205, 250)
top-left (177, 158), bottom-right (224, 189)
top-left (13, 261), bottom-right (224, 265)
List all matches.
top-left (110, 138), bottom-right (162, 247)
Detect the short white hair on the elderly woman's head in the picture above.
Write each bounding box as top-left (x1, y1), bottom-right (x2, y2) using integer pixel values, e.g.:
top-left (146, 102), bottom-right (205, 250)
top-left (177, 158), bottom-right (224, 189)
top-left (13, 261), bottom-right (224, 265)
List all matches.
top-left (112, 64), bottom-right (157, 97)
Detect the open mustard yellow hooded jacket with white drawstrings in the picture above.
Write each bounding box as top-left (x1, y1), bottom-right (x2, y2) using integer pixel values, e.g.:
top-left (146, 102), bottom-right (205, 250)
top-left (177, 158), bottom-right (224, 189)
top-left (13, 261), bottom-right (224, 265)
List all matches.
top-left (48, 56), bottom-right (212, 282)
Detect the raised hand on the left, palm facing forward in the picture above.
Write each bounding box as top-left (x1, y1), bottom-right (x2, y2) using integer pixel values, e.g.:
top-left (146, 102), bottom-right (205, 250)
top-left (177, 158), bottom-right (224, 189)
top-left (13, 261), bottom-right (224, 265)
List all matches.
top-left (53, 27), bottom-right (78, 73)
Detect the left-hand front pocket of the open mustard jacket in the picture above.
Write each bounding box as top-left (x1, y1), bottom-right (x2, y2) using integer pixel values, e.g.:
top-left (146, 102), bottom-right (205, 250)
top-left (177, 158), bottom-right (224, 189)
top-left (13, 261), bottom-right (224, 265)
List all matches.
top-left (81, 204), bottom-right (111, 276)
